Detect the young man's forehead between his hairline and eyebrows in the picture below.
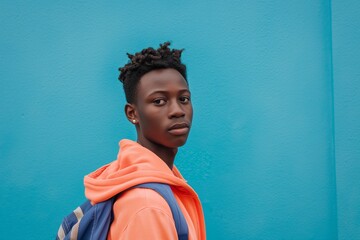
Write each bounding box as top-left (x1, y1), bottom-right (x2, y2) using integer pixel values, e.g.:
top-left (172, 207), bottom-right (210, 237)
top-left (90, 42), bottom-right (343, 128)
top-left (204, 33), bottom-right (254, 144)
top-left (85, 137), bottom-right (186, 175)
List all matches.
top-left (137, 68), bottom-right (188, 94)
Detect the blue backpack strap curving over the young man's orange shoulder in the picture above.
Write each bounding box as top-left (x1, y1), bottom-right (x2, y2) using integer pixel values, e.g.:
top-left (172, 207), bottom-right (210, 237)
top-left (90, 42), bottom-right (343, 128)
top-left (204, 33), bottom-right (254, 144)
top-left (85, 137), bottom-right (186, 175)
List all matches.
top-left (134, 183), bottom-right (189, 240)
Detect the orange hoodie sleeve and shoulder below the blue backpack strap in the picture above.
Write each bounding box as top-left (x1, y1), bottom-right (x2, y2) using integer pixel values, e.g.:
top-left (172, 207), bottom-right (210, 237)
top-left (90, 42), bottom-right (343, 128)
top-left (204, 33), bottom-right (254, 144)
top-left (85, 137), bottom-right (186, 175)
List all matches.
top-left (108, 188), bottom-right (177, 240)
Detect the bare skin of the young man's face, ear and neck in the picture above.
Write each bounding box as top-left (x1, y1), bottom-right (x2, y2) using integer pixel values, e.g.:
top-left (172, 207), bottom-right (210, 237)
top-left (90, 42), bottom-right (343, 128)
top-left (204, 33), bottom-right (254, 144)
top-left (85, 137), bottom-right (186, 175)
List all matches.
top-left (125, 68), bottom-right (193, 169)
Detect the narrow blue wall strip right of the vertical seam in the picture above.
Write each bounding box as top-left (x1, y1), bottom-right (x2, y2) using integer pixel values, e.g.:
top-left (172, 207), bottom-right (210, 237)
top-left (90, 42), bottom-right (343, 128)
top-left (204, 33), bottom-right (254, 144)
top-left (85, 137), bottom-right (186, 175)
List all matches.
top-left (332, 0), bottom-right (360, 240)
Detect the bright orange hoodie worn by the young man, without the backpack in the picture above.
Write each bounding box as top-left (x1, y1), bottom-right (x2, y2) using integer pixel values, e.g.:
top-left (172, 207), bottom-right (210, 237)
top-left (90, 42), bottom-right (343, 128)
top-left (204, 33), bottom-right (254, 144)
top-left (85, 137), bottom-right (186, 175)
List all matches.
top-left (84, 139), bottom-right (206, 240)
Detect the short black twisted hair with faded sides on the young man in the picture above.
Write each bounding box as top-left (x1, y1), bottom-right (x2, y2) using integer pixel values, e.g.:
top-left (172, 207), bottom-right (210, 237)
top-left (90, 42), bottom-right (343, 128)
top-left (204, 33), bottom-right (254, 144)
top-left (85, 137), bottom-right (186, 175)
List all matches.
top-left (119, 42), bottom-right (187, 103)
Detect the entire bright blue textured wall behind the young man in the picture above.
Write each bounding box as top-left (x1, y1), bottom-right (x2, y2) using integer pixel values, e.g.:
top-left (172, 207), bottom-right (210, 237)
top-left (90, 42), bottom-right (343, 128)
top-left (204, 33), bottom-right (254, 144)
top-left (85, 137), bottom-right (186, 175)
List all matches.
top-left (0, 0), bottom-right (360, 239)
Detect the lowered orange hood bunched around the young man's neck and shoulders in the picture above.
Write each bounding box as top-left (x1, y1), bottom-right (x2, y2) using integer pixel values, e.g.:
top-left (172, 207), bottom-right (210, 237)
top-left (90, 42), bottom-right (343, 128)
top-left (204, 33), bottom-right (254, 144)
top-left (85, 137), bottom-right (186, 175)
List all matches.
top-left (84, 139), bottom-right (190, 203)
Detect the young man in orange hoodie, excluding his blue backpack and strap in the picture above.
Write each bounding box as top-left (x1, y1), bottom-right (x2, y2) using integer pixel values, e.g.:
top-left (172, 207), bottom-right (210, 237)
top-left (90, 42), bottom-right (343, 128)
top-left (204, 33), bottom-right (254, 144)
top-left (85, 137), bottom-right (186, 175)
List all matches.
top-left (84, 42), bottom-right (206, 240)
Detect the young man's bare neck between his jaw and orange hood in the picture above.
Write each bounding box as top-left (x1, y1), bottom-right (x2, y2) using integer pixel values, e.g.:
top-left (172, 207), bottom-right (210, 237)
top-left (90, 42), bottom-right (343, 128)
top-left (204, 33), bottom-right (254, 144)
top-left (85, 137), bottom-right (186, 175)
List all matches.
top-left (137, 138), bottom-right (178, 170)
